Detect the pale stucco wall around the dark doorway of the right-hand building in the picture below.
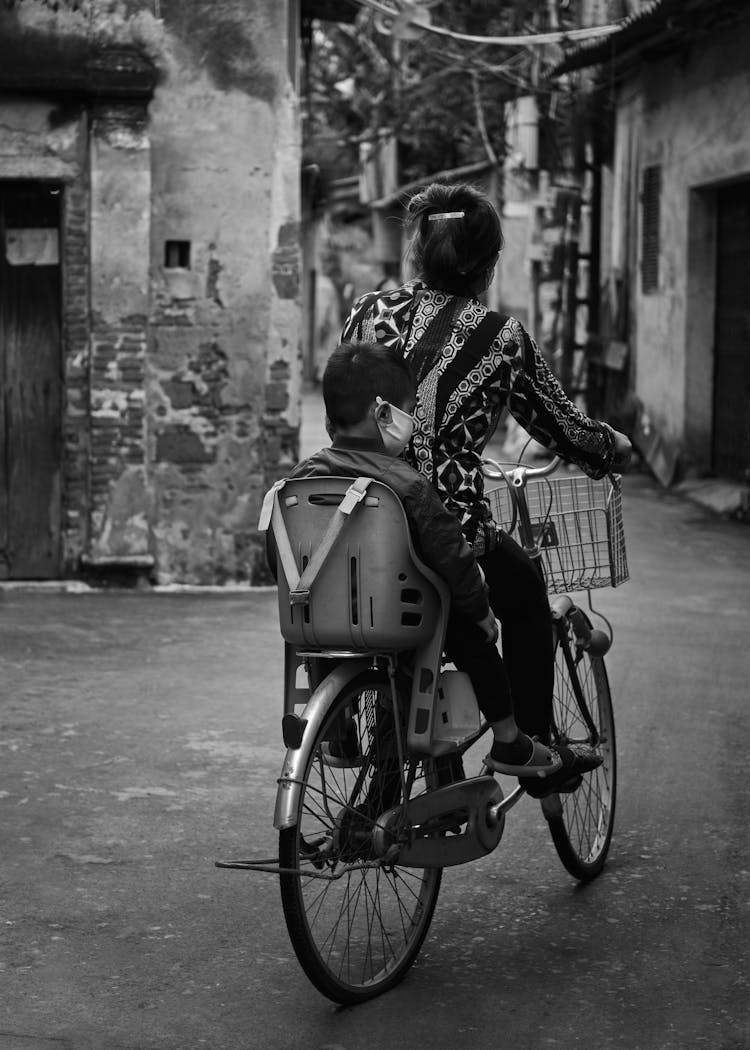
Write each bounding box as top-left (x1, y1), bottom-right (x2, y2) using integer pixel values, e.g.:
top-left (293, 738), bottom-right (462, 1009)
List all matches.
top-left (614, 18), bottom-right (750, 460)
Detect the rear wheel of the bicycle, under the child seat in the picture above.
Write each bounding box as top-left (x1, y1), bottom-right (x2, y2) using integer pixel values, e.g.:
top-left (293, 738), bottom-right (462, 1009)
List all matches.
top-left (279, 669), bottom-right (442, 1005)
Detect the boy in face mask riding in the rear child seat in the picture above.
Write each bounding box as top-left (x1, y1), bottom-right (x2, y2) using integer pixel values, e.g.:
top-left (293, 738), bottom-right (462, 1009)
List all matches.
top-left (283, 342), bottom-right (602, 797)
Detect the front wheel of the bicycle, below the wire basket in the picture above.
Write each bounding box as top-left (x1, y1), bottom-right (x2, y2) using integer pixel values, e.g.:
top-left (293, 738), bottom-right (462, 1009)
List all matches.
top-left (542, 616), bottom-right (617, 882)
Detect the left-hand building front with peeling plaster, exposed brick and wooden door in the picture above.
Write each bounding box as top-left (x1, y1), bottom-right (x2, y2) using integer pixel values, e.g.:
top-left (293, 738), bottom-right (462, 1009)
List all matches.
top-left (0, 0), bottom-right (299, 584)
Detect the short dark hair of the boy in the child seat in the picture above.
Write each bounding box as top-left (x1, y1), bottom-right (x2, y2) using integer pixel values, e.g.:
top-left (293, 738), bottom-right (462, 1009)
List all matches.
top-left (322, 342), bottom-right (416, 427)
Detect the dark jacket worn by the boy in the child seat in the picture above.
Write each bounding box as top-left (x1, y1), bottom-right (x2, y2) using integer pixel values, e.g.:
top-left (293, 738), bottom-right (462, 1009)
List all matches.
top-left (290, 437), bottom-right (489, 623)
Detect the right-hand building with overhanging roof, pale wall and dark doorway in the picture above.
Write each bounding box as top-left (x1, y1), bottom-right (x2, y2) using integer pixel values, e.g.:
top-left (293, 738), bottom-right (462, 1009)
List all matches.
top-left (558, 0), bottom-right (750, 482)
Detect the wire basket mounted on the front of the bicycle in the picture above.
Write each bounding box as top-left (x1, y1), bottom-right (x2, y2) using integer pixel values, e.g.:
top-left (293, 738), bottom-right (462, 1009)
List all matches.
top-left (486, 475), bottom-right (629, 594)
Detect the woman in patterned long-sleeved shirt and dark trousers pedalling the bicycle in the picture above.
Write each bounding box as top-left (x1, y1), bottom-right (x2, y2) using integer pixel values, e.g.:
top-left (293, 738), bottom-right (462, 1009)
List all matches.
top-left (341, 183), bottom-right (630, 794)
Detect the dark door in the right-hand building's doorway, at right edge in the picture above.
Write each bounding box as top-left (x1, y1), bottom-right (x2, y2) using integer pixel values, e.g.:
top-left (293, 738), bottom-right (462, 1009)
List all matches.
top-left (713, 183), bottom-right (750, 480)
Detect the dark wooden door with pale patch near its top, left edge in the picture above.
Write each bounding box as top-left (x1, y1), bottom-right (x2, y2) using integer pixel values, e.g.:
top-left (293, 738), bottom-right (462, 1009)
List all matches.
top-left (0, 182), bottom-right (62, 580)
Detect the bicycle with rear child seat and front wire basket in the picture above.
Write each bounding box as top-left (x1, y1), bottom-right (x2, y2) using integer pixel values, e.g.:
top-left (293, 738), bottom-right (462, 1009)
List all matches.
top-left (216, 460), bottom-right (627, 1005)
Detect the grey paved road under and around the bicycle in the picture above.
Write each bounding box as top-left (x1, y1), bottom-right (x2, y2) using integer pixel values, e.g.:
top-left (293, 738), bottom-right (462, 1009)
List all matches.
top-left (0, 477), bottom-right (750, 1050)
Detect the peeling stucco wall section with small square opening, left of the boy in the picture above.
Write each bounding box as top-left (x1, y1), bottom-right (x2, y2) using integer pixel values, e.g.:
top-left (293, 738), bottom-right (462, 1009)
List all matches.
top-left (147, 4), bottom-right (298, 582)
